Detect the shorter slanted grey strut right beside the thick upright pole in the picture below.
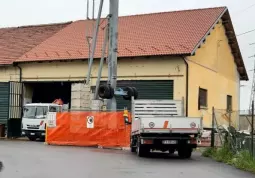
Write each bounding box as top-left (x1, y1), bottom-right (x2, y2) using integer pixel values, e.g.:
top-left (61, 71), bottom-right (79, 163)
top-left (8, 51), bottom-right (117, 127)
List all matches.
top-left (94, 25), bottom-right (108, 99)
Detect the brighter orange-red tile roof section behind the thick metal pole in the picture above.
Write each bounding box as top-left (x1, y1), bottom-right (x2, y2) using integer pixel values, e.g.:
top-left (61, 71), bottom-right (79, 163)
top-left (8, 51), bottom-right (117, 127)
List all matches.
top-left (17, 7), bottom-right (226, 62)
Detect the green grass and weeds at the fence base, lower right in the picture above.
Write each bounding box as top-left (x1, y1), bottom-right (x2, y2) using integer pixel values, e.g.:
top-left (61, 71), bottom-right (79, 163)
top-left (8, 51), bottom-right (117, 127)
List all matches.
top-left (202, 145), bottom-right (255, 173)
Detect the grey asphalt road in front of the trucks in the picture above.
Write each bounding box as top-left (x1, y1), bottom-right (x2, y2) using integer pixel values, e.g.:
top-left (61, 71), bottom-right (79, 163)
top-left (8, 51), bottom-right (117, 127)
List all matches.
top-left (0, 141), bottom-right (255, 178)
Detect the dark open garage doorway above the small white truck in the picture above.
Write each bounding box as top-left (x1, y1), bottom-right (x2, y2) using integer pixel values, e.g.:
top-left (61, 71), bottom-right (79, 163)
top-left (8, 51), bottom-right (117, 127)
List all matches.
top-left (24, 82), bottom-right (72, 109)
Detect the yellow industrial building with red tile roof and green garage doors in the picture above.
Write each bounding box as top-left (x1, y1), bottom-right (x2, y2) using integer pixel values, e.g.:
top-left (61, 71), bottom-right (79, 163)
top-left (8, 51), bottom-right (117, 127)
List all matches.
top-left (0, 7), bottom-right (248, 135)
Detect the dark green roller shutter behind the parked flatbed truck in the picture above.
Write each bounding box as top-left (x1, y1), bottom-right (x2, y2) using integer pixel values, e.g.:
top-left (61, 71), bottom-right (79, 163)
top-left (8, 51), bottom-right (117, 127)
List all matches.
top-left (94, 80), bottom-right (174, 110)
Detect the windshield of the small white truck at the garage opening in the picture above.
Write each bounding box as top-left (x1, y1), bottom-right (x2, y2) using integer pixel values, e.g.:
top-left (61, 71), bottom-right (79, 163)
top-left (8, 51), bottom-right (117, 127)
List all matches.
top-left (23, 106), bottom-right (48, 119)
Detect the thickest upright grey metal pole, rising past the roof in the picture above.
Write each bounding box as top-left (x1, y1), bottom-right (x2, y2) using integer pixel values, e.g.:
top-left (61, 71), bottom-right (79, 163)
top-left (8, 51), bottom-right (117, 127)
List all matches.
top-left (107, 0), bottom-right (119, 111)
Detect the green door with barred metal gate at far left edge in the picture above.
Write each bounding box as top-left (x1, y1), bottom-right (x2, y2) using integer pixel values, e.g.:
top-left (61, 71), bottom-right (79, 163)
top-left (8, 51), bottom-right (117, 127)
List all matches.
top-left (0, 82), bottom-right (23, 137)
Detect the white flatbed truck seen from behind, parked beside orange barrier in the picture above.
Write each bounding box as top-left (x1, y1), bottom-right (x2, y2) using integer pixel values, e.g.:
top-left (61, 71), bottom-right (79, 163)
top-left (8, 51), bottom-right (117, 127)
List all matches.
top-left (130, 99), bottom-right (203, 158)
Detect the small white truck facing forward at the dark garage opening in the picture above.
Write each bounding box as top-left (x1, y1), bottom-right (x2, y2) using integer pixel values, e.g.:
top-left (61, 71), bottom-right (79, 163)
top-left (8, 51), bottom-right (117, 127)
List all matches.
top-left (21, 103), bottom-right (62, 141)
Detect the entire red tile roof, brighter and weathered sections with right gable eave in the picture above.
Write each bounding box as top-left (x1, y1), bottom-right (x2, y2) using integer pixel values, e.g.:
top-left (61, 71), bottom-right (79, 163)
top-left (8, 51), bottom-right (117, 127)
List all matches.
top-left (0, 7), bottom-right (248, 80)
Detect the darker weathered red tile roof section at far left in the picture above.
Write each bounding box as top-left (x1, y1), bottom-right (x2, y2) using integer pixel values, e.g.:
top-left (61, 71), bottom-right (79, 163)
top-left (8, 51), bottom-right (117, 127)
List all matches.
top-left (0, 23), bottom-right (70, 65)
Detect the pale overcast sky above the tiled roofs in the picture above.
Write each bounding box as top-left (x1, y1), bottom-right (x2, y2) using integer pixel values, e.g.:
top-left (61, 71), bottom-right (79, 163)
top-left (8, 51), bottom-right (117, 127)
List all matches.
top-left (0, 0), bottom-right (255, 109)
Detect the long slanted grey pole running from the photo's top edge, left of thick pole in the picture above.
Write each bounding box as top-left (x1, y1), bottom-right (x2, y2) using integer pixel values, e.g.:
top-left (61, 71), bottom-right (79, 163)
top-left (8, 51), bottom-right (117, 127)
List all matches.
top-left (86, 0), bottom-right (104, 84)
